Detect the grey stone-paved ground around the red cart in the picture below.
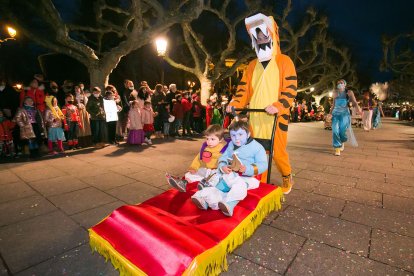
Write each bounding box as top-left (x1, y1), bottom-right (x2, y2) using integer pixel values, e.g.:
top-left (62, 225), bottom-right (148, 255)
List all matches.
top-left (0, 119), bottom-right (414, 275)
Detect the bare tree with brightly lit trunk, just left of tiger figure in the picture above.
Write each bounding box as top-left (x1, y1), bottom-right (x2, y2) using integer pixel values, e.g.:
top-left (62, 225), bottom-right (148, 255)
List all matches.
top-left (165, 0), bottom-right (263, 103)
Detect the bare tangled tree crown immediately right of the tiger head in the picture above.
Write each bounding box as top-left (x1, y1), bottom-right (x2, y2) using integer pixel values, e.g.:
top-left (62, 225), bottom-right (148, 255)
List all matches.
top-left (276, 0), bottom-right (357, 94)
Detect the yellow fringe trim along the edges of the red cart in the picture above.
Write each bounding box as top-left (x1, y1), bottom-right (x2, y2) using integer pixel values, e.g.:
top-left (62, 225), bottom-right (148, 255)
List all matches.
top-left (89, 187), bottom-right (283, 276)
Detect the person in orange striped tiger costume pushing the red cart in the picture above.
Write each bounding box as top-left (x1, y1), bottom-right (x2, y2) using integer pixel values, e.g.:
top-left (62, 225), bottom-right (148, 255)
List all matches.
top-left (227, 13), bottom-right (297, 194)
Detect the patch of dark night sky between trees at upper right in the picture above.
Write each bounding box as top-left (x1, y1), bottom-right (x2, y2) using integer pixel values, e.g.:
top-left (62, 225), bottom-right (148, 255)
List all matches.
top-left (293, 0), bottom-right (414, 82)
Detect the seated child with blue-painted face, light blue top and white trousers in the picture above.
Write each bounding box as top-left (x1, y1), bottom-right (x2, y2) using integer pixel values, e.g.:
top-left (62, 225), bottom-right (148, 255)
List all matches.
top-left (191, 121), bottom-right (268, 216)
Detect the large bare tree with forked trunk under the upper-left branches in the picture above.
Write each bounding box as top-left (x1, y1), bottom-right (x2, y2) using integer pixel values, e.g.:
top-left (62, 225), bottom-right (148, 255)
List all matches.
top-left (0, 0), bottom-right (203, 87)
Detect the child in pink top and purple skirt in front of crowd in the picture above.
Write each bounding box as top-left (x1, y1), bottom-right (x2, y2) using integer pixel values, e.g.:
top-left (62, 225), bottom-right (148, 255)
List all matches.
top-left (127, 101), bottom-right (145, 145)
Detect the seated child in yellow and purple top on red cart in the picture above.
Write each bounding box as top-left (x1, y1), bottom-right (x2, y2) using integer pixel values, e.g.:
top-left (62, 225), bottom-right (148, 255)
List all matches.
top-left (166, 125), bottom-right (227, 192)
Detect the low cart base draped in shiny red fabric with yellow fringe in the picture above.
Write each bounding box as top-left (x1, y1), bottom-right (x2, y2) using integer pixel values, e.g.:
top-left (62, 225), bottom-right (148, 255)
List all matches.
top-left (89, 183), bottom-right (283, 275)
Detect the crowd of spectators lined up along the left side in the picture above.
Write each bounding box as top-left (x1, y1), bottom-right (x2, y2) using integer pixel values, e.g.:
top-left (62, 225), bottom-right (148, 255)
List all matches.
top-left (0, 75), bottom-right (233, 157)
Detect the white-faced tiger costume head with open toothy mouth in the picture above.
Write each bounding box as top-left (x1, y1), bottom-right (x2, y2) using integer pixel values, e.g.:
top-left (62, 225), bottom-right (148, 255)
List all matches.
top-left (244, 13), bottom-right (280, 62)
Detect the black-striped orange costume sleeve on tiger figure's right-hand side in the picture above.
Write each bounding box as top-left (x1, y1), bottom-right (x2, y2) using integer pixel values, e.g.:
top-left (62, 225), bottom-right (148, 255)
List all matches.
top-left (273, 55), bottom-right (298, 116)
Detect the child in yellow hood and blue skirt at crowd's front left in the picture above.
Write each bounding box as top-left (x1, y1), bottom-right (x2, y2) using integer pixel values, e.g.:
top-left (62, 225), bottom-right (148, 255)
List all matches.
top-left (45, 96), bottom-right (67, 155)
